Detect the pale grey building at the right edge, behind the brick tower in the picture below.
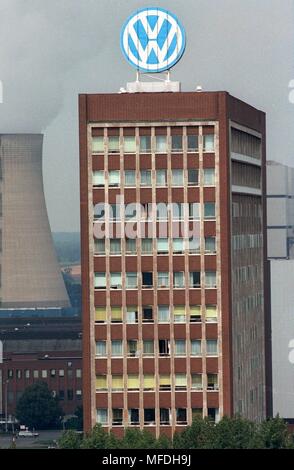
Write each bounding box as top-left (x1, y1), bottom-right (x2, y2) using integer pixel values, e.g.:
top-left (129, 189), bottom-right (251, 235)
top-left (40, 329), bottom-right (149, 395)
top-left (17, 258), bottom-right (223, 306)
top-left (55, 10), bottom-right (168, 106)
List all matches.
top-left (267, 161), bottom-right (294, 418)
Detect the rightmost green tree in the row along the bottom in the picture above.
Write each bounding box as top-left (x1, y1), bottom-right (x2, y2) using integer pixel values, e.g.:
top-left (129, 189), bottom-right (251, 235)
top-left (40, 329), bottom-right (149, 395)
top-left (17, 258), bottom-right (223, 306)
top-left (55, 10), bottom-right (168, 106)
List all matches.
top-left (256, 415), bottom-right (292, 449)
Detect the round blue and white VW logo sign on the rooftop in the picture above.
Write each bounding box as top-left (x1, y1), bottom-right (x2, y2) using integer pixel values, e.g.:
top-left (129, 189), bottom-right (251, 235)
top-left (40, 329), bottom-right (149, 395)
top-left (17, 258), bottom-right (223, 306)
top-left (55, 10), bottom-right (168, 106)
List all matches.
top-left (121, 7), bottom-right (186, 73)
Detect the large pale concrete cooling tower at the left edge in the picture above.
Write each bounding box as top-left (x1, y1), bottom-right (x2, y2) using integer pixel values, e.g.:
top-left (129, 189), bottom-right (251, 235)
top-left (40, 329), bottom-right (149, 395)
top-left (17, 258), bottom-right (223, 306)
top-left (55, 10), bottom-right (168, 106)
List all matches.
top-left (0, 134), bottom-right (70, 308)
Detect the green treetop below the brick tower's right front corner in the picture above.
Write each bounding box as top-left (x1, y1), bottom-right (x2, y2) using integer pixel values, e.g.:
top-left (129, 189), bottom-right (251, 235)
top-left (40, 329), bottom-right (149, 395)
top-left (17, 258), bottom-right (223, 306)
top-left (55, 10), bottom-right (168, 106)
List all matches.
top-left (214, 416), bottom-right (256, 449)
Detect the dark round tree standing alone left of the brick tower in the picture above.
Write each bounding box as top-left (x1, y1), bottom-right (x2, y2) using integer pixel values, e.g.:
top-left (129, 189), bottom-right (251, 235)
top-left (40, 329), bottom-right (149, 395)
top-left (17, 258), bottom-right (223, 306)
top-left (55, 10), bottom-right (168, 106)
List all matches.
top-left (16, 382), bottom-right (63, 429)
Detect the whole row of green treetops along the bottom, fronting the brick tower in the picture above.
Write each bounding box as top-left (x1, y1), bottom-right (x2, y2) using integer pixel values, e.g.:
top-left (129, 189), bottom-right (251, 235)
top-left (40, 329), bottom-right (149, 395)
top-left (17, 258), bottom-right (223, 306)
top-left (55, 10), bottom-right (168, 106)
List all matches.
top-left (59, 416), bottom-right (294, 449)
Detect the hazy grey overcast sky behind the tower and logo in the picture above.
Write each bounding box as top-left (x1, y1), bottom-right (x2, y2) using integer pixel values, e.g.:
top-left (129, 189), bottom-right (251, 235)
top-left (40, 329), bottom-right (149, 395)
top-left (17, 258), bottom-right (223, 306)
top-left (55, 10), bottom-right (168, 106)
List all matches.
top-left (0, 0), bottom-right (294, 231)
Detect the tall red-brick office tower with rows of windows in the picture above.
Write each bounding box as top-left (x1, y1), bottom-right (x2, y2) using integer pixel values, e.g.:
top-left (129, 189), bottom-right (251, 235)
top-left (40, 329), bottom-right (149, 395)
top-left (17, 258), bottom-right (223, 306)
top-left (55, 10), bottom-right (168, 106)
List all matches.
top-left (80, 92), bottom-right (270, 435)
